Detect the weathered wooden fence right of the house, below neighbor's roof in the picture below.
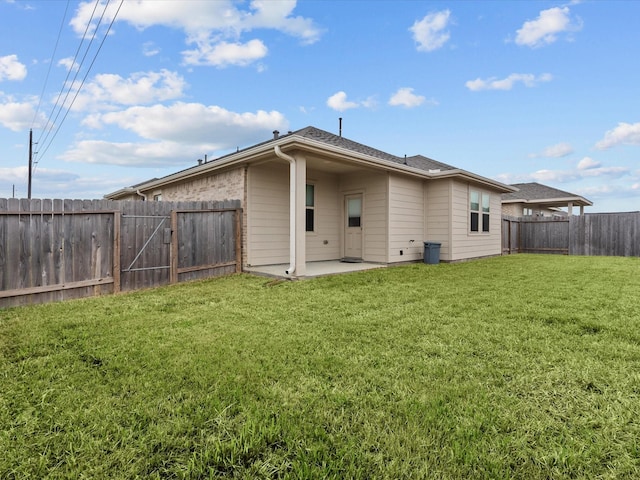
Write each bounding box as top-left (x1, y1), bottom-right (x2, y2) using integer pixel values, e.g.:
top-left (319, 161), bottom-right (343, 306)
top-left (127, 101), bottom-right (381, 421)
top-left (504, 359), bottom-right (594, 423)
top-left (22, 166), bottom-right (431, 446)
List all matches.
top-left (502, 212), bottom-right (640, 257)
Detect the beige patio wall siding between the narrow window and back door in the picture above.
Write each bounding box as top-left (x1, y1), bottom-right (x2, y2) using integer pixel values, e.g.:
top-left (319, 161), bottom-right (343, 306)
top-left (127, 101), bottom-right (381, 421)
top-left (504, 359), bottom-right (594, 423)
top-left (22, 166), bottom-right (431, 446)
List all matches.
top-left (306, 170), bottom-right (342, 262)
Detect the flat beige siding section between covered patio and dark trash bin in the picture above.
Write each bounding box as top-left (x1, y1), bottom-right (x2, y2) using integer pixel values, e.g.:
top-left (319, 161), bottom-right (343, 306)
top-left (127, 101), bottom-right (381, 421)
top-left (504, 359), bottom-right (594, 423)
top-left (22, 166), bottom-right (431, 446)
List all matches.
top-left (389, 175), bottom-right (424, 263)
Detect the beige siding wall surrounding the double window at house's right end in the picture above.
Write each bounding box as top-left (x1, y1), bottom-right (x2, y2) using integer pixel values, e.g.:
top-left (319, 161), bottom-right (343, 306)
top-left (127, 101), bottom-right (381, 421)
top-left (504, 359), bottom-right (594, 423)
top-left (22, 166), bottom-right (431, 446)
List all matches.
top-left (451, 181), bottom-right (502, 261)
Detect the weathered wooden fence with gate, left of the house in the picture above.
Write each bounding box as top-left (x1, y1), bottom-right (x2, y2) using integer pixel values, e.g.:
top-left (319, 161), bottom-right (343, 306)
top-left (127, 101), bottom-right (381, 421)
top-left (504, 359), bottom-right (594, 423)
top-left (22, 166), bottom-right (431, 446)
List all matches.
top-left (0, 199), bottom-right (242, 307)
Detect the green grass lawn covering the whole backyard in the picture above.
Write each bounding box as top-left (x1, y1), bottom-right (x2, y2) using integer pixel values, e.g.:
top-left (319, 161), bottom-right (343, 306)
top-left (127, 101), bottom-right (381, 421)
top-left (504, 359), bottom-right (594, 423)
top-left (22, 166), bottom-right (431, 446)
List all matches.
top-left (0, 255), bottom-right (640, 479)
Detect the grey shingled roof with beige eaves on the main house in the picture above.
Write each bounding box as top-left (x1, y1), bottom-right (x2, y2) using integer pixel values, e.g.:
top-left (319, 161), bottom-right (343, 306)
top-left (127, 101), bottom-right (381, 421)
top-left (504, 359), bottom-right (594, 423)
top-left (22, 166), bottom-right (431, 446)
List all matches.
top-left (105, 126), bottom-right (515, 199)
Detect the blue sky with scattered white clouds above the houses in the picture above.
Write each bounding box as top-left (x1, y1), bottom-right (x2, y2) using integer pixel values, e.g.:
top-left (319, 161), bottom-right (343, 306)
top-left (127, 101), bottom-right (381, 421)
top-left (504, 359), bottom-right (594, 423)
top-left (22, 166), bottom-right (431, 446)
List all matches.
top-left (0, 0), bottom-right (640, 212)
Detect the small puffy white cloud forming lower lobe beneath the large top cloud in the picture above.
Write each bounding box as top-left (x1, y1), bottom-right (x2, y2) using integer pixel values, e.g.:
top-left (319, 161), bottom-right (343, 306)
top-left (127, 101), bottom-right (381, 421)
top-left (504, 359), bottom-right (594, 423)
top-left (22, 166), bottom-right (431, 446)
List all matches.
top-left (182, 39), bottom-right (268, 68)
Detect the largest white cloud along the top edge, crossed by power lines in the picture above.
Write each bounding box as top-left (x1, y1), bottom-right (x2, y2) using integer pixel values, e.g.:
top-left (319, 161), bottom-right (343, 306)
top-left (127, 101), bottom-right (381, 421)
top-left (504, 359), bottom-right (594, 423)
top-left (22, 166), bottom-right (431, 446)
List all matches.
top-left (71, 0), bottom-right (322, 67)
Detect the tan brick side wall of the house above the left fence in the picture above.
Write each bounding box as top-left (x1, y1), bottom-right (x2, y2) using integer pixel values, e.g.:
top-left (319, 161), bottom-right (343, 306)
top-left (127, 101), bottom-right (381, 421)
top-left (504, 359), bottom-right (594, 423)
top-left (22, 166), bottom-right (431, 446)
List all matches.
top-left (158, 167), bottom-right (247, 267)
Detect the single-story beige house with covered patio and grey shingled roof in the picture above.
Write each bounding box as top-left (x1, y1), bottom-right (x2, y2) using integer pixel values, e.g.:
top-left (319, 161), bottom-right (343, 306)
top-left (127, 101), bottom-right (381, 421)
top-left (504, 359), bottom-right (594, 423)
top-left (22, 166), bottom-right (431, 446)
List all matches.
top-left (106, 127), bottom-right (515, 277)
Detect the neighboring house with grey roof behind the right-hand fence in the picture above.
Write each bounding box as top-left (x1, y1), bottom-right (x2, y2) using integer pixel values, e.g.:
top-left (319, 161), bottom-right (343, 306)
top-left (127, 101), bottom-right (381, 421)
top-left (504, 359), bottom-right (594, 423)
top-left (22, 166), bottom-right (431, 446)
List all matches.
top-left (502, 182), bottom-right (593, 217)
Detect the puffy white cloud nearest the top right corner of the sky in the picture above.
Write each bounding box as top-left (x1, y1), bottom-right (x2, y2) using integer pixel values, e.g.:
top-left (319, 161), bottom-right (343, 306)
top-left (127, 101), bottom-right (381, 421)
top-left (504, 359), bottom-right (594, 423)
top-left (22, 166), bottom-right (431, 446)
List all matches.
top-left (516, 7), bottom-right (582, 48)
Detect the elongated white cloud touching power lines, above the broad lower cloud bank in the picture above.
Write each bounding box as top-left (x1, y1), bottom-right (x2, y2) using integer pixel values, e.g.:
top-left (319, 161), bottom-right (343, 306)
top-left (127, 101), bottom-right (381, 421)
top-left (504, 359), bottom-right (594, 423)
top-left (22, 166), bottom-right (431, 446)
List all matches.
top-left (73, 70), bottom-right (187, 111)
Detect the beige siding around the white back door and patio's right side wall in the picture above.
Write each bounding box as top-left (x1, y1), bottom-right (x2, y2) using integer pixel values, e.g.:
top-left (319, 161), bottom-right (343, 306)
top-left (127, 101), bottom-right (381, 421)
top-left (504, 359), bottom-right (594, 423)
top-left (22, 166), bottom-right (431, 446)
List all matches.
top-left (340, 172), bottom-right (388, 263)
